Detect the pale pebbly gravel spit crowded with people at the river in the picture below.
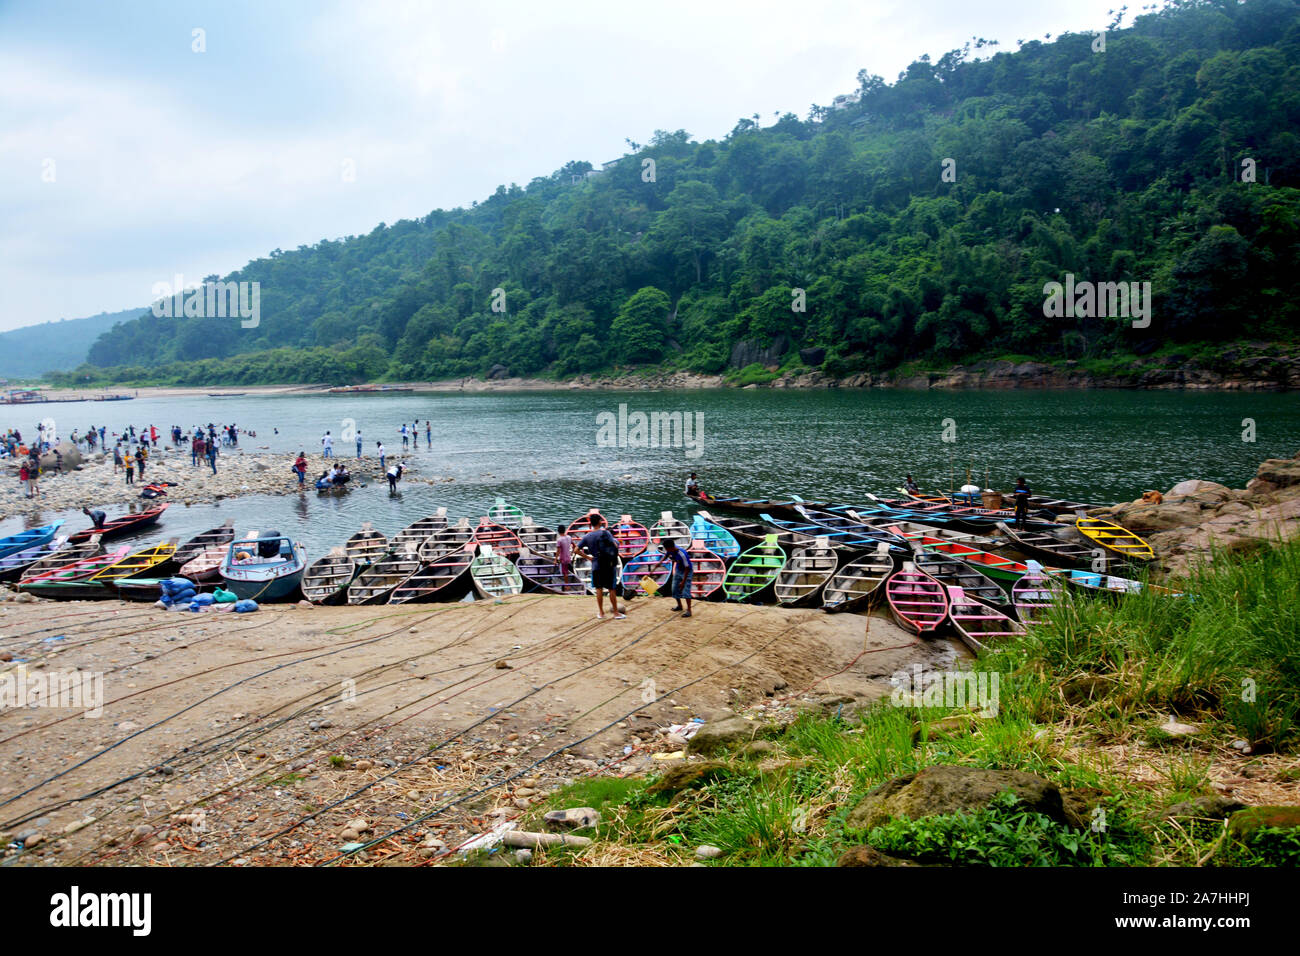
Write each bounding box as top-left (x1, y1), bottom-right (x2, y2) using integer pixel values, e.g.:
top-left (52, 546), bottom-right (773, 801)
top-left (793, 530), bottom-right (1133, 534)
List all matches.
top-left (0, 440), bottom-right (451, 516)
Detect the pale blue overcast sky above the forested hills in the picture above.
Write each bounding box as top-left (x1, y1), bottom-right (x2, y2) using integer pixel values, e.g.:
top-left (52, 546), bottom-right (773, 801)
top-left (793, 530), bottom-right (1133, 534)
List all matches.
top-left (0, 0), bottom-right (1136, 329)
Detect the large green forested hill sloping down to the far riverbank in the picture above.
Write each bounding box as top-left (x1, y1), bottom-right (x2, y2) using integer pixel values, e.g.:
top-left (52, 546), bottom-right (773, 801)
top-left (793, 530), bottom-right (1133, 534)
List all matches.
top-left (76, 0), bottom-right (1300, 382)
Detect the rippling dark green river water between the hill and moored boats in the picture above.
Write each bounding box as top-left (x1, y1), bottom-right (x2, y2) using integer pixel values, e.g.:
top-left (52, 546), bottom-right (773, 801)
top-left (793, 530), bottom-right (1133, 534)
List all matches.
top-left (0, 389), bottom-right (1300, 557)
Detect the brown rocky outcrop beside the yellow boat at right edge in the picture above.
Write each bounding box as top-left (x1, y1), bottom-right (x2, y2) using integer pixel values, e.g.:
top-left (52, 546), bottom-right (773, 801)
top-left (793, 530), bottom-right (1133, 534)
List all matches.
top-left (1101, 454), bottom-right (1300, 574)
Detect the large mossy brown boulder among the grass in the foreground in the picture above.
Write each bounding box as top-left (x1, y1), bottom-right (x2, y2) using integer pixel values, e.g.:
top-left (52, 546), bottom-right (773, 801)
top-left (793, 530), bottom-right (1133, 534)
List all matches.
top-left (846, 765), bottom-right (1082, 831)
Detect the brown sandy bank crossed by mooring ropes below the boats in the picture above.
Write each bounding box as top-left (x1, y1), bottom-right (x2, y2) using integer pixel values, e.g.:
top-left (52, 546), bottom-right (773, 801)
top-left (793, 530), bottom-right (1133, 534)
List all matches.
top-left (0, 596), bottom-right (941, 865)
